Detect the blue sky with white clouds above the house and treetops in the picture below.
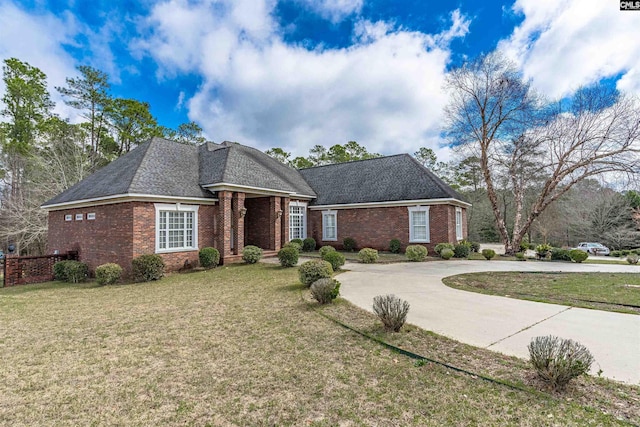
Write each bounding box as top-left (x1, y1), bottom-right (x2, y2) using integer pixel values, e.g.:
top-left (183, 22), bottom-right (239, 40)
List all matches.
top-left (0, 0), bottom-right (640, 160)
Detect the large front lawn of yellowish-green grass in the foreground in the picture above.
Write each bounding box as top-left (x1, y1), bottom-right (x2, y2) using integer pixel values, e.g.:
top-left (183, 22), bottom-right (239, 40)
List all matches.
top-left (0, 264), bottom-right (640, 426)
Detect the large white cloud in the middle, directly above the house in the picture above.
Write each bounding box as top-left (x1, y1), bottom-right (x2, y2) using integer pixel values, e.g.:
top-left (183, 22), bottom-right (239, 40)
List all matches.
top-left (133, 0), bottom-right (468, 155)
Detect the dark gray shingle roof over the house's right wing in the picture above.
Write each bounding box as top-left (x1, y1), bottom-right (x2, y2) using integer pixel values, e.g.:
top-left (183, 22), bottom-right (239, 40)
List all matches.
top-left (300, 154), bottom-right (464, 205)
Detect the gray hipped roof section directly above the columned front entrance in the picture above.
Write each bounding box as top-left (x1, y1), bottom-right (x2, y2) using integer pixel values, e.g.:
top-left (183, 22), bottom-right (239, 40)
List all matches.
top-left (200, 142), bottom-right (316, 196)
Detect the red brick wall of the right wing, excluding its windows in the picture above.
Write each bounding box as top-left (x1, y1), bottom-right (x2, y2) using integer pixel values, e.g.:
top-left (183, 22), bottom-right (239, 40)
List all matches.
top-left (307, 205), bottom-right (466, 252)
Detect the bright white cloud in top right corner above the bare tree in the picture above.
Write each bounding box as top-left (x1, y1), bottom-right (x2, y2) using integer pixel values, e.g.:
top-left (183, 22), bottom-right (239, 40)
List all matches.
top-left (499, 0), bottom-right (640, 97)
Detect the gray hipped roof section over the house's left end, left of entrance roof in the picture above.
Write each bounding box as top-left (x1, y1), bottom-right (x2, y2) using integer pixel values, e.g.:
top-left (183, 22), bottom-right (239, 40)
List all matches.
top-left (43, 138), bottom-right (213, 207)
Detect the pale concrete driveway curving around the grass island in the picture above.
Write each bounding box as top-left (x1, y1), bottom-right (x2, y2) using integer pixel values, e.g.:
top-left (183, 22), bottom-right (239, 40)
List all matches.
top-left (339, 261), bottom-right (640, 384)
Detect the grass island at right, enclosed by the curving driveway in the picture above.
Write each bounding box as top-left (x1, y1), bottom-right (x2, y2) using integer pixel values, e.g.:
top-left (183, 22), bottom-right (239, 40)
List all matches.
top-left (443, 272), bottom-right (640, 314)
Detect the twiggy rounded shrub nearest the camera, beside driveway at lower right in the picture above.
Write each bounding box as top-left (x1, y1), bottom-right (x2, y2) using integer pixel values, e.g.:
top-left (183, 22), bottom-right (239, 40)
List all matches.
top-left (528, 335), bottom-right (593, 390)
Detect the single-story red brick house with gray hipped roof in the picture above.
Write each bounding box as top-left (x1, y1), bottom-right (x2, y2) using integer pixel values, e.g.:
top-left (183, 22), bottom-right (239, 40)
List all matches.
top-left (42, 138), bottom-right (470, 271)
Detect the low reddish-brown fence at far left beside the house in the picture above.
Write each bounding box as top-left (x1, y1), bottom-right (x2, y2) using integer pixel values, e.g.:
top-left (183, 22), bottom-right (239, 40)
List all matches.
top-left (4, 251), bottom-right (78, 287)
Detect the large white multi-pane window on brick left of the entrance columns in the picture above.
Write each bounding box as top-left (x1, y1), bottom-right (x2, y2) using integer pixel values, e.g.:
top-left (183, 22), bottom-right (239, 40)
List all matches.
top-left (155, 203), bottom-right (198, 252)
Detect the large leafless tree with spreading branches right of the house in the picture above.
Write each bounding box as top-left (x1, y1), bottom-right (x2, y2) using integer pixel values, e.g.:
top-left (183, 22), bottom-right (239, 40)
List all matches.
top-left (445, 53), bottom-right (640, 253)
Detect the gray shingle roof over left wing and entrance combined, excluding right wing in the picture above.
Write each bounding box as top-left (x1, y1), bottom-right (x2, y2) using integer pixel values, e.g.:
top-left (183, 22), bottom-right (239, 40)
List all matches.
top-left (42, 138), bottom-right (315, 207)
